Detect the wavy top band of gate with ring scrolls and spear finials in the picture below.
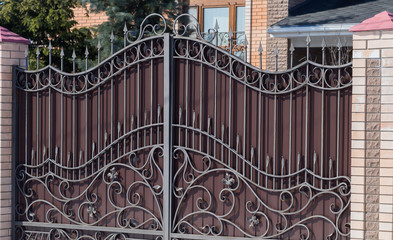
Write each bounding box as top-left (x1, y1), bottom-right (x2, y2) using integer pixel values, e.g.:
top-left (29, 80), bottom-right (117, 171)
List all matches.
top-left (16, 13), bottom-right (352, 95)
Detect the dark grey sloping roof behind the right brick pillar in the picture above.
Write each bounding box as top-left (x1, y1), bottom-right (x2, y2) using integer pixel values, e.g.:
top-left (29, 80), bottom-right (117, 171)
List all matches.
top-left (272, 0), bottom-right (393, 27)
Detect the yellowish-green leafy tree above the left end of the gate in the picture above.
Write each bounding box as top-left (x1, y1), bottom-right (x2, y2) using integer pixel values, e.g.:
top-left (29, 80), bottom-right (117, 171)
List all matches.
top-left (0, 0), bottom-right (95, 71)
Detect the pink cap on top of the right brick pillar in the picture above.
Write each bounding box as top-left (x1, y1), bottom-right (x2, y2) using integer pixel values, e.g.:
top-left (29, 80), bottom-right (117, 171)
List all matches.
top-left (349, 11), bottom-right (393, 32)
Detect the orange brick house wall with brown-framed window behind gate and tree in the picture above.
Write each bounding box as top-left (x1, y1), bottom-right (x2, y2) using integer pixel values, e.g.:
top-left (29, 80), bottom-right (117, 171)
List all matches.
top-left (74, 0), bottom-right (305, 69)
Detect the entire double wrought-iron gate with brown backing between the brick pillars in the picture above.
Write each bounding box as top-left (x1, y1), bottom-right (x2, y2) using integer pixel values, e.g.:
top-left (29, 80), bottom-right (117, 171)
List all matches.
top-left (14, 14), bottom-right (352, 240)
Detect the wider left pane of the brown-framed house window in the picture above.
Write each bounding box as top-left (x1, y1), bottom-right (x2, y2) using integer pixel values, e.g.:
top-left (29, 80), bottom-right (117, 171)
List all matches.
top-left (203, 7), bottom-right (229, 32)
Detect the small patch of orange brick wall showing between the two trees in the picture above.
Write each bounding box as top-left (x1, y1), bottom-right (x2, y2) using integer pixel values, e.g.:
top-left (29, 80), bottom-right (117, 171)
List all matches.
top-left (74, 5), bottom-right (108, 28)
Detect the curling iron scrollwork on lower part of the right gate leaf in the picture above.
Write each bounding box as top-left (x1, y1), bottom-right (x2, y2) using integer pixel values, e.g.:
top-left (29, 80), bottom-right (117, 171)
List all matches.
top-left (173, 147), bottom-right (350, 239)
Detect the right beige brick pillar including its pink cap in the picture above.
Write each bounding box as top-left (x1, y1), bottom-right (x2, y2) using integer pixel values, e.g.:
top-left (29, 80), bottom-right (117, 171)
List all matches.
top-left (351, 12), bottom-right (393, 239)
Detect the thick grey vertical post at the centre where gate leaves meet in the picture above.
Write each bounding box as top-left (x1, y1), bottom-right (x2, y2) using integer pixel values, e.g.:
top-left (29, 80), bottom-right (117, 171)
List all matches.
top-left (163, 33), bottom-right (173, 240)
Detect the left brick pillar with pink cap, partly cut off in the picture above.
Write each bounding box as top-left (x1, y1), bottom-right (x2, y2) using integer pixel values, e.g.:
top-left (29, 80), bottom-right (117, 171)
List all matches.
top-left (0, 27), bottom-right (29, 240)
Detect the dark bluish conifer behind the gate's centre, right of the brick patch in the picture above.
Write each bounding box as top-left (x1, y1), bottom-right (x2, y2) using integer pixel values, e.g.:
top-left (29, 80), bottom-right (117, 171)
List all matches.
top-left (81, 0), bottom-right (182, 59)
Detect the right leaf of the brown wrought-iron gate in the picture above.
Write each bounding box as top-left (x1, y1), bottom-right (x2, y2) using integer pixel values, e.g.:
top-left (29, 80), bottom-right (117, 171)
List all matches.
top-left (173, 38), bottom-right (351, 239)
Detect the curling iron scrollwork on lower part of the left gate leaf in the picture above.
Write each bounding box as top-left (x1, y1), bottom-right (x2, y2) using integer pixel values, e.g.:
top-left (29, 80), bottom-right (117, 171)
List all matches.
top-left (16, 146), bottom-right (162, 230)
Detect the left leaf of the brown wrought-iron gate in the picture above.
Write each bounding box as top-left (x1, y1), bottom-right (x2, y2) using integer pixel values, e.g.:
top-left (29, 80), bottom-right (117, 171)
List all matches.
top-left (16, 36), bottom-right (163, 238)
